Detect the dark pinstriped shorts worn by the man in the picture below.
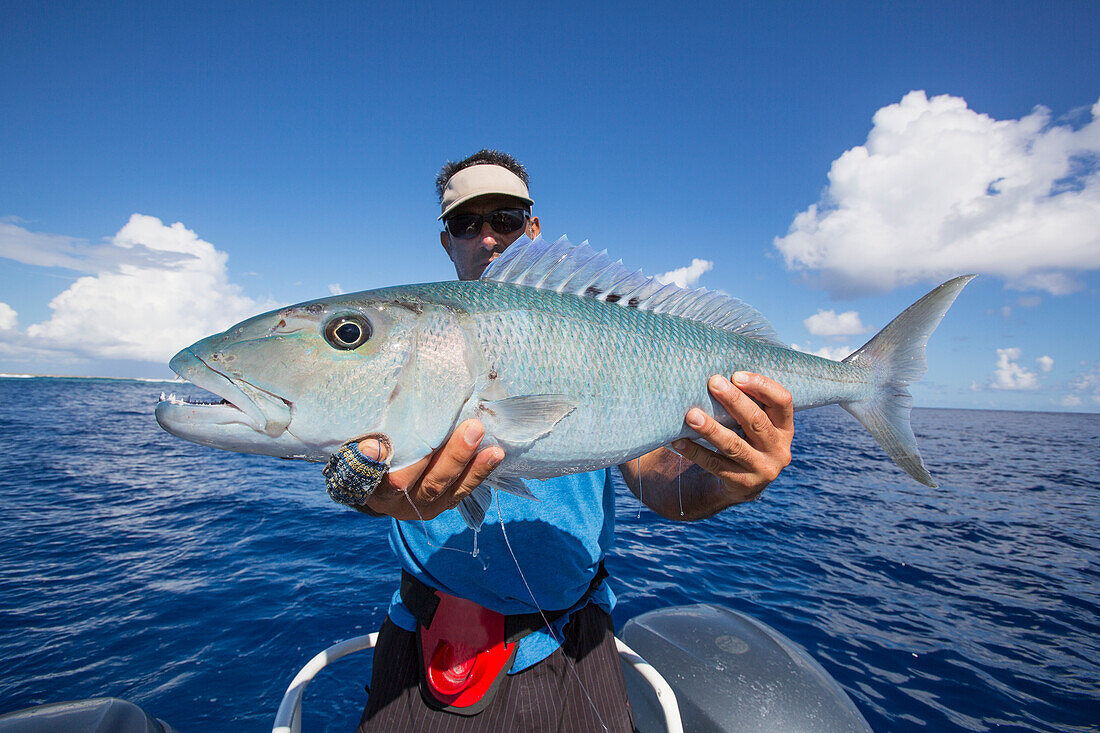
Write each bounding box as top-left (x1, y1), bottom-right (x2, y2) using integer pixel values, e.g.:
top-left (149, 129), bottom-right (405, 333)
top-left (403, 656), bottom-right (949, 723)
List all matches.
top-left (359, 603), bottom-right (634, 733)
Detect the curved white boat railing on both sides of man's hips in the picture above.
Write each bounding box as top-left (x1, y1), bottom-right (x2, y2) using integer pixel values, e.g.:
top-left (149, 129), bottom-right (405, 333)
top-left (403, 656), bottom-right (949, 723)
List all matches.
top-left (272, 632), bottom-right (683, 733)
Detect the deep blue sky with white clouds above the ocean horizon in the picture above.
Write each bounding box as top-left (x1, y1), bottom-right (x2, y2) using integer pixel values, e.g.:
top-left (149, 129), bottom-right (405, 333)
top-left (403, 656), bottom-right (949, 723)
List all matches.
top-left (0, 2), bottom-right (1100, 412)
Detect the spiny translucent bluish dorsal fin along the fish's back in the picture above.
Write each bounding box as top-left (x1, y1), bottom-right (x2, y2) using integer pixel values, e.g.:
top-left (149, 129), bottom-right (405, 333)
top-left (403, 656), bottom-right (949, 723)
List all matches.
top-left (482, 237), bottom-right (779, 343)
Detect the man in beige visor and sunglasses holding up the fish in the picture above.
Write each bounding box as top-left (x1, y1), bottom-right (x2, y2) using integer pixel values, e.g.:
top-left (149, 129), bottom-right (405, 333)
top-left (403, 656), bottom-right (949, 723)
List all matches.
top-left (349, 150), bottom-right (793, 733)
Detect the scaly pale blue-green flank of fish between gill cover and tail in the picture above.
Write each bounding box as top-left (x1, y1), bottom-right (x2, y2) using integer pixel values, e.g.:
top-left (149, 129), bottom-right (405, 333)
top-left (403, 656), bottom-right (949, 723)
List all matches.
top-left (446, 278), bottom-right (873, 478)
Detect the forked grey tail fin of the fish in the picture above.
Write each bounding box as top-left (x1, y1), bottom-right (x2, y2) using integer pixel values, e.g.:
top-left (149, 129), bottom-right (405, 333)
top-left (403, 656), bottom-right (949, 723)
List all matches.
top-left (840, 275), bottom-right (976, 488)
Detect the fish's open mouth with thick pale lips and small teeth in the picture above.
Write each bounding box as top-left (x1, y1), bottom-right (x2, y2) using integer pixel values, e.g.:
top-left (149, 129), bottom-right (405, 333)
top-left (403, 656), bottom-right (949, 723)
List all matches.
top-left (157, 348), bottom-right (293, 438)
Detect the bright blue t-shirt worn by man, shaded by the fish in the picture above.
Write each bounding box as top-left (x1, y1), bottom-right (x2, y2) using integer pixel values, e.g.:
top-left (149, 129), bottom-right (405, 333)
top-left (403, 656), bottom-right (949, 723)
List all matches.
top-left (389, 469), bottom-right (615, 672)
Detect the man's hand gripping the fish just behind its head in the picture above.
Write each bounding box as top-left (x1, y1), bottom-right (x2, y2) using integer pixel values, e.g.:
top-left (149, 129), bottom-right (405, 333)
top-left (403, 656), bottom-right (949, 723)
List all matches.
top-left (359, 420), bottom-right (504, 519)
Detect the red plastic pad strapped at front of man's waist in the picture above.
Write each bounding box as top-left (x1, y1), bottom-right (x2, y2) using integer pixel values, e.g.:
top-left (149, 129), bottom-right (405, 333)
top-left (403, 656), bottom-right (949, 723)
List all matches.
top-left (420, 591), bottom-right (516, 714)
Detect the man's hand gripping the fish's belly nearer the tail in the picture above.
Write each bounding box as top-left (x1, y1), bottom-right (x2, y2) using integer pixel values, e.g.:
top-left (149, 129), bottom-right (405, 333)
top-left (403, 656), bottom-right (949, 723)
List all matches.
top-left (673, 372), bottom-right (794, 504)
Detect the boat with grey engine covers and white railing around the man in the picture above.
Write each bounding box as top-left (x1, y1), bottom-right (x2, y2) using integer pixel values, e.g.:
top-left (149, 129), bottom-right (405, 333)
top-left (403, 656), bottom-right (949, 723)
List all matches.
top-left (0, 603), bottom-right (871, 733)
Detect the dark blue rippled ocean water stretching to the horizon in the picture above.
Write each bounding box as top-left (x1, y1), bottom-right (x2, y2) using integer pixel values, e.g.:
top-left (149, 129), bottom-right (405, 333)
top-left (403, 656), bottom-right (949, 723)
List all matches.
top-left (0, 379), bottom-right (1100, 732)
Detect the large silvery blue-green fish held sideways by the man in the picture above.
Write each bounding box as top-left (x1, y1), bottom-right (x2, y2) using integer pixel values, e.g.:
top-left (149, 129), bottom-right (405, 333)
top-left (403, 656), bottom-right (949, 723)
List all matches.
top-left (155, 237), bottom-right (974, 529)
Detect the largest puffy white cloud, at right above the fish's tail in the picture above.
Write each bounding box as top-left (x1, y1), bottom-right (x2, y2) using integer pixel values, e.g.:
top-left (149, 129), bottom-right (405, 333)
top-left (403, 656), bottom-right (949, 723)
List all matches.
top-left (774, 91), bottom-right (1100, 295)
